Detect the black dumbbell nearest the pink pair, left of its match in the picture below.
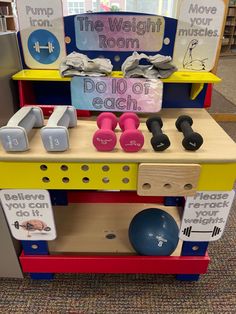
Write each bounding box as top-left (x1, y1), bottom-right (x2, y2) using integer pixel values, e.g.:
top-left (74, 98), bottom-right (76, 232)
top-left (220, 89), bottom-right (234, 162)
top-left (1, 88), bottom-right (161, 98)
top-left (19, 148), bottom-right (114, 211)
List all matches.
top-left (146, 116), bottom-right (170, 151)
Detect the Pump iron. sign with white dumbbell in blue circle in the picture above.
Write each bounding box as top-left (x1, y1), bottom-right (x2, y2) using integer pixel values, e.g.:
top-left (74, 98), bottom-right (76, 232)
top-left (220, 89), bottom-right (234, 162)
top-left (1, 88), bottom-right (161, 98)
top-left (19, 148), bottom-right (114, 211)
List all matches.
top-left (17, 0), bottom-right (66, 69)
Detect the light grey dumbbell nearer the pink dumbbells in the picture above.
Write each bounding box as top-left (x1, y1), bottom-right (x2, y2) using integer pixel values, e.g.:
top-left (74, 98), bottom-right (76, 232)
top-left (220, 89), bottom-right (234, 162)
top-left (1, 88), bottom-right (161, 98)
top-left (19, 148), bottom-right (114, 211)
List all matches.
top-left (41, 106), bottom-right (77, 152)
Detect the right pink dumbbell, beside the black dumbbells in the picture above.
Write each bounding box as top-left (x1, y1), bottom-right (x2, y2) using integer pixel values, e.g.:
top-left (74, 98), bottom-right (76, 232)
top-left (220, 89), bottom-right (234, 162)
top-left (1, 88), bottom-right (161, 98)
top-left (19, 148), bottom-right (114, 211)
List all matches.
top-left (119, 112), bottom-right (144, 152)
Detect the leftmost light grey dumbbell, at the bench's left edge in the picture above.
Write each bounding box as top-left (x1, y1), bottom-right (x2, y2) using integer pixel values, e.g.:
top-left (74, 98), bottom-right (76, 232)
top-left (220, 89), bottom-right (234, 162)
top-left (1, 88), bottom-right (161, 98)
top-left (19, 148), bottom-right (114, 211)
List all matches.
top-left (0, 106), bottom-right (44, 152)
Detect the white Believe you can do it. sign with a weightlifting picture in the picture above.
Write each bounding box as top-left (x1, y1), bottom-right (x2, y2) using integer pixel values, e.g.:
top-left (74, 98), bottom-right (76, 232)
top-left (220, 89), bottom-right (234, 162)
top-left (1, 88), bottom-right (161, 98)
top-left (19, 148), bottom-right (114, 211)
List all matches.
top-left (0, 190), bottom-right (56, 241)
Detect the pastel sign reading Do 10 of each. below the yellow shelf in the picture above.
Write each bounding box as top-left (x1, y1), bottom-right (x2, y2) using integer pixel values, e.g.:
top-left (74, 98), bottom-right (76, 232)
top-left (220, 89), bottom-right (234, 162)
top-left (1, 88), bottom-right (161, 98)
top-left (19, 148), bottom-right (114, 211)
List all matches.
top-left (71, 77), bottom-right (163, 112)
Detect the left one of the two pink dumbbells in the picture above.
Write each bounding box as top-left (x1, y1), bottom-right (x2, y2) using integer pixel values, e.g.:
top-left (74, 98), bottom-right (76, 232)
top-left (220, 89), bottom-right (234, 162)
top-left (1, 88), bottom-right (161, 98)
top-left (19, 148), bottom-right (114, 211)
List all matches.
top-left (93, 112), bottom-right (117, 152)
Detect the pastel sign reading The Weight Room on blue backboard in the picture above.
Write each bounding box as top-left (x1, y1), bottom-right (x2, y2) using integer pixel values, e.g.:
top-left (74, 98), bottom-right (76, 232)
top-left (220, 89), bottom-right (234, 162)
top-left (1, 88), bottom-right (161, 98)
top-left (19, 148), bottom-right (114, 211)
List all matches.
top-left (75, 14), bottom-right (165, 51)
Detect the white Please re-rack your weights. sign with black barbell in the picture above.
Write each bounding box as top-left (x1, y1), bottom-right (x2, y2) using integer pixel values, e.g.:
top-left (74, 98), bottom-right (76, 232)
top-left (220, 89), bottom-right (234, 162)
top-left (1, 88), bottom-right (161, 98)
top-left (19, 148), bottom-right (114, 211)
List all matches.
top-left (179, 191), bottom-right (235, 241)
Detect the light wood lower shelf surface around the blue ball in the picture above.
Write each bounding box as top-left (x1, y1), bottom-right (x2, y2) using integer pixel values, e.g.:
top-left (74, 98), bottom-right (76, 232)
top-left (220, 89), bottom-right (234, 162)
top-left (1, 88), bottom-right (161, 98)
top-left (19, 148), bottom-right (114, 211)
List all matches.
top-left (48, 203), bottom-right (182, 256)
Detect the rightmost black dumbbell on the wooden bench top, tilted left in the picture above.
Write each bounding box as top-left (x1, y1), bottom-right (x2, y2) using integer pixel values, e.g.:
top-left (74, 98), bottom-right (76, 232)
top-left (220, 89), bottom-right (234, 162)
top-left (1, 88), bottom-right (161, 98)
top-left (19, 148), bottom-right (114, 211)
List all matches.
top-left (175, 115), bottom-right (203, 150)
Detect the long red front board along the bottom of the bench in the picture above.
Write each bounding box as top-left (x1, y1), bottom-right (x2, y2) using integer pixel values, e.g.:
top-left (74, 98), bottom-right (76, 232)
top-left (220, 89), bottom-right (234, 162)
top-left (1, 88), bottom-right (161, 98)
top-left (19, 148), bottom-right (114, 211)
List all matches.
top-left (20, 253), bottom-right (210, 274)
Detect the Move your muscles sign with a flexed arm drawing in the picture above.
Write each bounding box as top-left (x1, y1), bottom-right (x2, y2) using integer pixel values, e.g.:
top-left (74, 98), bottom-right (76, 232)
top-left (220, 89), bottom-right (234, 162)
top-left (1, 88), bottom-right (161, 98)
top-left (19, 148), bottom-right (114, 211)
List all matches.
top-left (173, 0), bottom-right (225, 71)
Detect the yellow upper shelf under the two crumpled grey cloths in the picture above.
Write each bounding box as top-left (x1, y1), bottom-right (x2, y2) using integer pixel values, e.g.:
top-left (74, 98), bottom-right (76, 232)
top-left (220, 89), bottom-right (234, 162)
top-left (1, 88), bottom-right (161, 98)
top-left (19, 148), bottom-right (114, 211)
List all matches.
top-left (12, 70), bottom-right (221, 83)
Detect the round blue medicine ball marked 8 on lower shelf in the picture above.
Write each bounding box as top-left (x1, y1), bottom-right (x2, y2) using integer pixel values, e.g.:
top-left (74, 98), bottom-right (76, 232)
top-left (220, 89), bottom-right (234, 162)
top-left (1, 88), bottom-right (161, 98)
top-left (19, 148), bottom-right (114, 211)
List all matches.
top-left (129, 208), bottom-right (179, 256)
